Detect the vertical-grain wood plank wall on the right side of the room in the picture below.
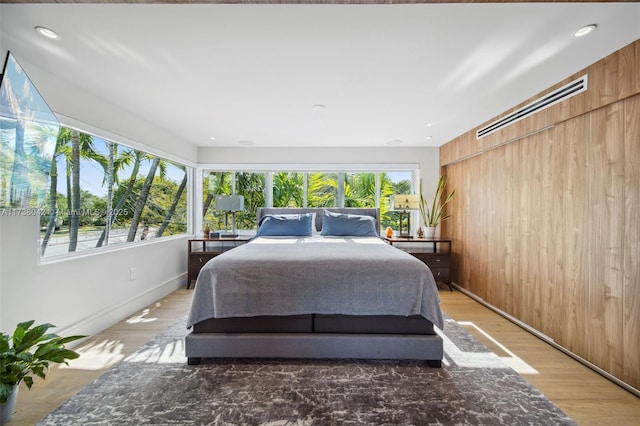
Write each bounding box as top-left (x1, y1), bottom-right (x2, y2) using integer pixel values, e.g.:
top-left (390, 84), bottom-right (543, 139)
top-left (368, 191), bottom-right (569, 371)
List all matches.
top-left (440, 40), bottom-right (640, 389)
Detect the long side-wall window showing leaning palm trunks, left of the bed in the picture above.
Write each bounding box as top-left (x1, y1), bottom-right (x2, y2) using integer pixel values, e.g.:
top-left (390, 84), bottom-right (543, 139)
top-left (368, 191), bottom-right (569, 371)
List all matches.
top-left (40, 127), bottom-right (188, 257)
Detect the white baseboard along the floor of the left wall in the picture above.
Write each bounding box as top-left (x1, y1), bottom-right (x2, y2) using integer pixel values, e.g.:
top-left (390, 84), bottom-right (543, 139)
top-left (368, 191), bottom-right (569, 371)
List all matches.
top-left (54, 273), bottom-right (187, 342)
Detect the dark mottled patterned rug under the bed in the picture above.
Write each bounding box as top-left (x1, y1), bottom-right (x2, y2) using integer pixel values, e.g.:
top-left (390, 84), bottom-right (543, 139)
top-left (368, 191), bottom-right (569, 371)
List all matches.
top-left (39, 317), bottom-right (575, 426)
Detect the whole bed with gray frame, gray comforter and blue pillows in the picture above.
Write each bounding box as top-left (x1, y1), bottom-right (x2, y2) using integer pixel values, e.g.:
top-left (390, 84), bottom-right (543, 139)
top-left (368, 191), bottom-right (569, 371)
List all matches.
top-left (185, 208), bottom-right (443, 367)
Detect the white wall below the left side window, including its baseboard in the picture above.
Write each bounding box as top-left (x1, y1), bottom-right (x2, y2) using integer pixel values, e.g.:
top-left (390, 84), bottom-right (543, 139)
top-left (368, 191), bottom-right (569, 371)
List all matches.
top-left (0, 215), bottom-right (187, 335)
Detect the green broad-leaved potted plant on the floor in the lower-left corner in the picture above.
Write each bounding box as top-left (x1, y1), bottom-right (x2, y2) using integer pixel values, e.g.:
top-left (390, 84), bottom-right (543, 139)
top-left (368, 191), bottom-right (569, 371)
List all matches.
top-left (0, 321), bottom-right (86, 424)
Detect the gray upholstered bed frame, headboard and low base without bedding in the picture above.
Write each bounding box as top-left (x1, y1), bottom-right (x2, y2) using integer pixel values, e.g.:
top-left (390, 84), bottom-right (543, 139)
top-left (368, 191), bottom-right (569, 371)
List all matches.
top-left (185, 208), bottom-right (444, 367)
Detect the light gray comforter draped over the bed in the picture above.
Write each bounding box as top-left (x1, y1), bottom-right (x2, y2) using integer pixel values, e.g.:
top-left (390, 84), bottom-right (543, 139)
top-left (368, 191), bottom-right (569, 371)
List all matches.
top-left (187, 236), bottom-right (443, 329)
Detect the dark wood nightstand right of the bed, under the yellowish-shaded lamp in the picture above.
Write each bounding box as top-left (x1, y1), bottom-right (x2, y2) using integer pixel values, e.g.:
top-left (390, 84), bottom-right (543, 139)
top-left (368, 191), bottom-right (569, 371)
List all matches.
top-left (383, 237), bottom-right (453, 291)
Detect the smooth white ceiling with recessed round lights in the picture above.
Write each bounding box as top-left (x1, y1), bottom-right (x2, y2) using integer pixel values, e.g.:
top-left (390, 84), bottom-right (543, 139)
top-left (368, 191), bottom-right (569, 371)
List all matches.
top-left (0, 3), bottom-right (640, 147)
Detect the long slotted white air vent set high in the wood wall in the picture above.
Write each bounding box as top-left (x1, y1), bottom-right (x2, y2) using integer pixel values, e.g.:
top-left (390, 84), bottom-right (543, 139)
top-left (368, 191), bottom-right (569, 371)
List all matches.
top-left (476, 74), bottom-right (587, 139)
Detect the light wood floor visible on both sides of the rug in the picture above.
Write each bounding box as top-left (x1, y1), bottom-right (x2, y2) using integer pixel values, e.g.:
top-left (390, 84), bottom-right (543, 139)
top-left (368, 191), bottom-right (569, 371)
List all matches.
top-left (8, 288), bottom-right (640, 426)
